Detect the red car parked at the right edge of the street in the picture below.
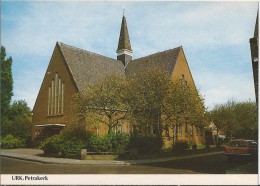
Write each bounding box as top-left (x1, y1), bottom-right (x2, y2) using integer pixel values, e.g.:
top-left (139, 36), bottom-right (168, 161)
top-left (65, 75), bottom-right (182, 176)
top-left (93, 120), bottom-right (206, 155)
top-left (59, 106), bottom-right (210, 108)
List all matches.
top-left (225, 139), bottom-right (258, 160)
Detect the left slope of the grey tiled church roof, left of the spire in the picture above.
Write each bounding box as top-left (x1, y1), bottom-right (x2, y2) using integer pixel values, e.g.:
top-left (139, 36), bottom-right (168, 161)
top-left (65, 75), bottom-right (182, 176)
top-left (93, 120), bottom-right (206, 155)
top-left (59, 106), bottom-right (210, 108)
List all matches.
top-left (57, 42), bottom-right (125, 91)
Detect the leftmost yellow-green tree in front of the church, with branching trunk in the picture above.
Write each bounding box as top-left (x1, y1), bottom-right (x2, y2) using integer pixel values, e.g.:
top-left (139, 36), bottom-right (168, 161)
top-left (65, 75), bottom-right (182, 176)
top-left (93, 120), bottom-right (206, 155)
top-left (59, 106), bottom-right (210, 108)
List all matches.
top-left (72, 75), bottom-right (127, 133)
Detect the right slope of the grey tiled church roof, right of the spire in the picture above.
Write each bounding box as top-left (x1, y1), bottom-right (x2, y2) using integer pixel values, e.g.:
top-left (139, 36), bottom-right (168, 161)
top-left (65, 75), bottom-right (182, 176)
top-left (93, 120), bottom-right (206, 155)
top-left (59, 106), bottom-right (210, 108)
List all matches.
top-left (125, 47), bottom-right (182, 78)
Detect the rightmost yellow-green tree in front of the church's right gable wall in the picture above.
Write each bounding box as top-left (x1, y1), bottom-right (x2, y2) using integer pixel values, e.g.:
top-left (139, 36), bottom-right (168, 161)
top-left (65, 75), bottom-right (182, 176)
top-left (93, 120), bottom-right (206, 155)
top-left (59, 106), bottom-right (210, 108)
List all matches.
top-left (163, 80), bottom-right (206, 140)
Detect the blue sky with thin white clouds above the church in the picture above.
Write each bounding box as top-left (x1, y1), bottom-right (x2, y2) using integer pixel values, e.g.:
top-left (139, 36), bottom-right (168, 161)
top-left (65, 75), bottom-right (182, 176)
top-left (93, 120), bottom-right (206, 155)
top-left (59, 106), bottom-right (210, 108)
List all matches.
top-left (1, 0), bottom-right (258, 110)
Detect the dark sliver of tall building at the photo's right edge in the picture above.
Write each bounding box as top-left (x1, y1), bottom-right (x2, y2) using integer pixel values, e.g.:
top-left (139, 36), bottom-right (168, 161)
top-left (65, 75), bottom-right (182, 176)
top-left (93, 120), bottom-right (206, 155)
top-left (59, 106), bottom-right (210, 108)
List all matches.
top-left (250, 12), bottom-right (259, 105)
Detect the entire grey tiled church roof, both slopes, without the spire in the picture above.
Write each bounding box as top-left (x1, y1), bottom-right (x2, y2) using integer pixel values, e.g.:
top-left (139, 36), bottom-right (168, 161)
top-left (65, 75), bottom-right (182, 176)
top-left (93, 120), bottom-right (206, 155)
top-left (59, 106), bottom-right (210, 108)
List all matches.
top-left (57, 42), bottom-right (182, 91)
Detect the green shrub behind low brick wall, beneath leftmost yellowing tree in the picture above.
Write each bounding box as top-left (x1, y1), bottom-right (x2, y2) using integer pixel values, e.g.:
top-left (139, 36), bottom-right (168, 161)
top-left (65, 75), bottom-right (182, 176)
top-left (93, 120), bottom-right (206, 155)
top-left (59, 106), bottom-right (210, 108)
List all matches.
top-left (89, 133), bottom-right (129, 153)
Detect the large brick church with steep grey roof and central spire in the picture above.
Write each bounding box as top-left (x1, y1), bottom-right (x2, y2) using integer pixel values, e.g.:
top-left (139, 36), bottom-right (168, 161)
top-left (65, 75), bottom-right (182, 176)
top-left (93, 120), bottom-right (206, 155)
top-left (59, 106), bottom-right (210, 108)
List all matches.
top-left (32, 16), bottom-right (204, 146)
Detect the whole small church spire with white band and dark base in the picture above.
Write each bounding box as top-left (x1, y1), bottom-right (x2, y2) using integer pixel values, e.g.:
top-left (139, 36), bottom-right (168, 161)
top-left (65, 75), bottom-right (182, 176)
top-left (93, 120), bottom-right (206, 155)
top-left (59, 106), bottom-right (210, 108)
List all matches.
top-left (116, 15), bottom-right (133, 67)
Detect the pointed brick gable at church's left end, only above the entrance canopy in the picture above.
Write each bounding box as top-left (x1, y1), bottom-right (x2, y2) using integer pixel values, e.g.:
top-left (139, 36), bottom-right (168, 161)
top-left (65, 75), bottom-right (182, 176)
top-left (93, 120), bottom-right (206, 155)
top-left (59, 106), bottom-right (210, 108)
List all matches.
top-left (33, 45), bottom-right (78, 124)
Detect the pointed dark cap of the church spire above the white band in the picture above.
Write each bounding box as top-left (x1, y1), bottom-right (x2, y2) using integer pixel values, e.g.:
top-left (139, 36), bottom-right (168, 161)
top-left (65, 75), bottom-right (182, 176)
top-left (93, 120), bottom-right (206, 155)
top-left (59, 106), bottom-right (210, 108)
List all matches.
top-left (117, 16), bottom-right (132, 52)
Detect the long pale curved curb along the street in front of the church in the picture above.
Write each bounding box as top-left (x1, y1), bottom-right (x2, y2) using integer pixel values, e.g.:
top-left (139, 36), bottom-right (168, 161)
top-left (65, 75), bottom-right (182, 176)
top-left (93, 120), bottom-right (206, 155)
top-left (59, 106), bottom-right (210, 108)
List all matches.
top-left (1, 151), bottom-right (224, 165)
